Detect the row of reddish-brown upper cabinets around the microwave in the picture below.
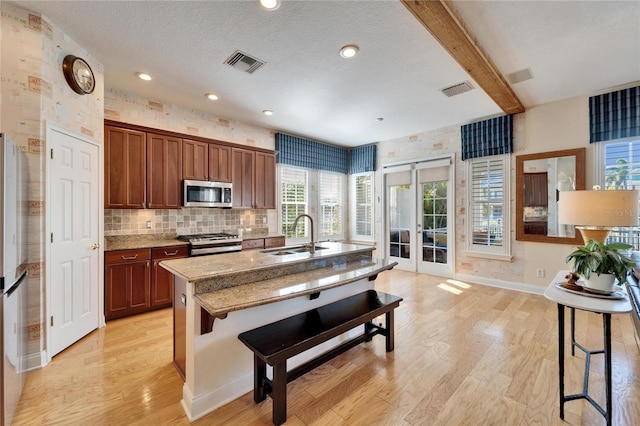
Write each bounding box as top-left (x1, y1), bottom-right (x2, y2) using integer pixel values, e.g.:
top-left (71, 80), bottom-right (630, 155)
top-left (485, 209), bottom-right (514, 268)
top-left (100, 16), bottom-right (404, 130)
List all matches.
top-left (104, 120), bottom-right (276, 209)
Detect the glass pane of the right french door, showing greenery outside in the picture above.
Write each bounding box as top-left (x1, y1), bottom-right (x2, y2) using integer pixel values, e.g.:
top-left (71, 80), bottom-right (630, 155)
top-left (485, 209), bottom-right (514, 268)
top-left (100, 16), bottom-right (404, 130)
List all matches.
top-left (422, 181), bottom-right (447, 263)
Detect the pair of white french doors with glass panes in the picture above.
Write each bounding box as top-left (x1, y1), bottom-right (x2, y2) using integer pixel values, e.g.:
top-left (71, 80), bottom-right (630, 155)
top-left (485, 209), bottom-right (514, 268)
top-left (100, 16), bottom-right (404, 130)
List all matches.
top-left (384, 157), bottom-right (455, 277)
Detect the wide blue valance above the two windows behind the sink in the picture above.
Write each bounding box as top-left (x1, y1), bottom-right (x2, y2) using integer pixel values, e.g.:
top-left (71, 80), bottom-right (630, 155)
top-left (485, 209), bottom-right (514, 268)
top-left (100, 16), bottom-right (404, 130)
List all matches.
top-left (276, 133), bottom-right (348, 174)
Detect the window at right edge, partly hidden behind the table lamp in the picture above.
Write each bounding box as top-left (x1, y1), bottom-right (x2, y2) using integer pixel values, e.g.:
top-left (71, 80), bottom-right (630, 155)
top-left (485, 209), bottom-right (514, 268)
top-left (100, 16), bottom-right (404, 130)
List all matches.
top-left (596, 138), bottom-right (640, 250)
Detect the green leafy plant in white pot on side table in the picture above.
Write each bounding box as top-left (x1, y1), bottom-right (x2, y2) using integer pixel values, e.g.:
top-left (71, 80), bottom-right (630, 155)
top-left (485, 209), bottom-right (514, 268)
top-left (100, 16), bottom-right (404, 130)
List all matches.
top-left (565, 239), bottom-right (636, 291)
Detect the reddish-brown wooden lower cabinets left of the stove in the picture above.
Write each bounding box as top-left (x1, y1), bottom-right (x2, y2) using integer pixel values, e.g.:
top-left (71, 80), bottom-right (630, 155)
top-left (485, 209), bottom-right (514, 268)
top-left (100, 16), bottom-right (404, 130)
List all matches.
top-left (105, 245), bottom-right (188, 320)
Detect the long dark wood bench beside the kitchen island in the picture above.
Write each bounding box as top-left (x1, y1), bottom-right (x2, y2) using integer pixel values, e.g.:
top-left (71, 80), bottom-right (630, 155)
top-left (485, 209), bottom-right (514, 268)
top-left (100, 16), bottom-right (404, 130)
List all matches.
top-left (238, 290), bottom-right (402, 425)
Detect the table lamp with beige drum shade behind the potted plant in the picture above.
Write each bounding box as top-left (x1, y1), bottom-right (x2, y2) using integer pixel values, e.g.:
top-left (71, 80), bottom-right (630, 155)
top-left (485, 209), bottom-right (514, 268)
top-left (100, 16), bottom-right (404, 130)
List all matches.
top-left (558, 190), bottom-right (640, 245)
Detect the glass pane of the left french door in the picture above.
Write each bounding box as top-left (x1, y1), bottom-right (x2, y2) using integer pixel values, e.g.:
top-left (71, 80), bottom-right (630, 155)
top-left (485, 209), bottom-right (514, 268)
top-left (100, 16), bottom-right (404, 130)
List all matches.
top-left (389, 185), bottom-right (411, 259)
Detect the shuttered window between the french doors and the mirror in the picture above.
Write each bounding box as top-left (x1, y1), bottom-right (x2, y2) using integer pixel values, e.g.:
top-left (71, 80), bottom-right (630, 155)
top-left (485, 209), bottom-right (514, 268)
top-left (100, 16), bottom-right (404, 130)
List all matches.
top-left (467, 154), bottom-right (510, 258)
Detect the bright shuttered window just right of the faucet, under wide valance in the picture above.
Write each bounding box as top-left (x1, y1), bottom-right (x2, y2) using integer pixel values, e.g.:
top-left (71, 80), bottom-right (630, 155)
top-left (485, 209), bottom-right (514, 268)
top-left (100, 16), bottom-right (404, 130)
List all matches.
top-left (318, 171), bottom-right (344, 239)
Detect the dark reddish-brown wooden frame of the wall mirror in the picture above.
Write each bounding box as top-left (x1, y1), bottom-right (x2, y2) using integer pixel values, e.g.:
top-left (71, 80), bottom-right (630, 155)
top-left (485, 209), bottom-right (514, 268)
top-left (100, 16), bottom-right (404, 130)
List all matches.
top-left (515, 148), bottom-right (587, 245)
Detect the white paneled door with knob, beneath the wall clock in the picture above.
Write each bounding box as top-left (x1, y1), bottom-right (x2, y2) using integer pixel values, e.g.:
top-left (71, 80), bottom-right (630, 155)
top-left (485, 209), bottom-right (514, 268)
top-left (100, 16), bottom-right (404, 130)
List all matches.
top-left (47, 126), bottom-right (102, 357)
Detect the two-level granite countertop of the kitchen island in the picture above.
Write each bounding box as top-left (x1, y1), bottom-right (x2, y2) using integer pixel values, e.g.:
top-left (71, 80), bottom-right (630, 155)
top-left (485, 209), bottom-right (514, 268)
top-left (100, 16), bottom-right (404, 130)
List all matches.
top-left (160, 242), bottom-right (397, 316)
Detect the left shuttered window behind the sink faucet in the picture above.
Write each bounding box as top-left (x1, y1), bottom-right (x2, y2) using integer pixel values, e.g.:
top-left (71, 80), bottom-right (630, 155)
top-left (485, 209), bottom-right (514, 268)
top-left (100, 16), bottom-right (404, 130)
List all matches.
top-left (280, 167), bottom-right (310, 238)
